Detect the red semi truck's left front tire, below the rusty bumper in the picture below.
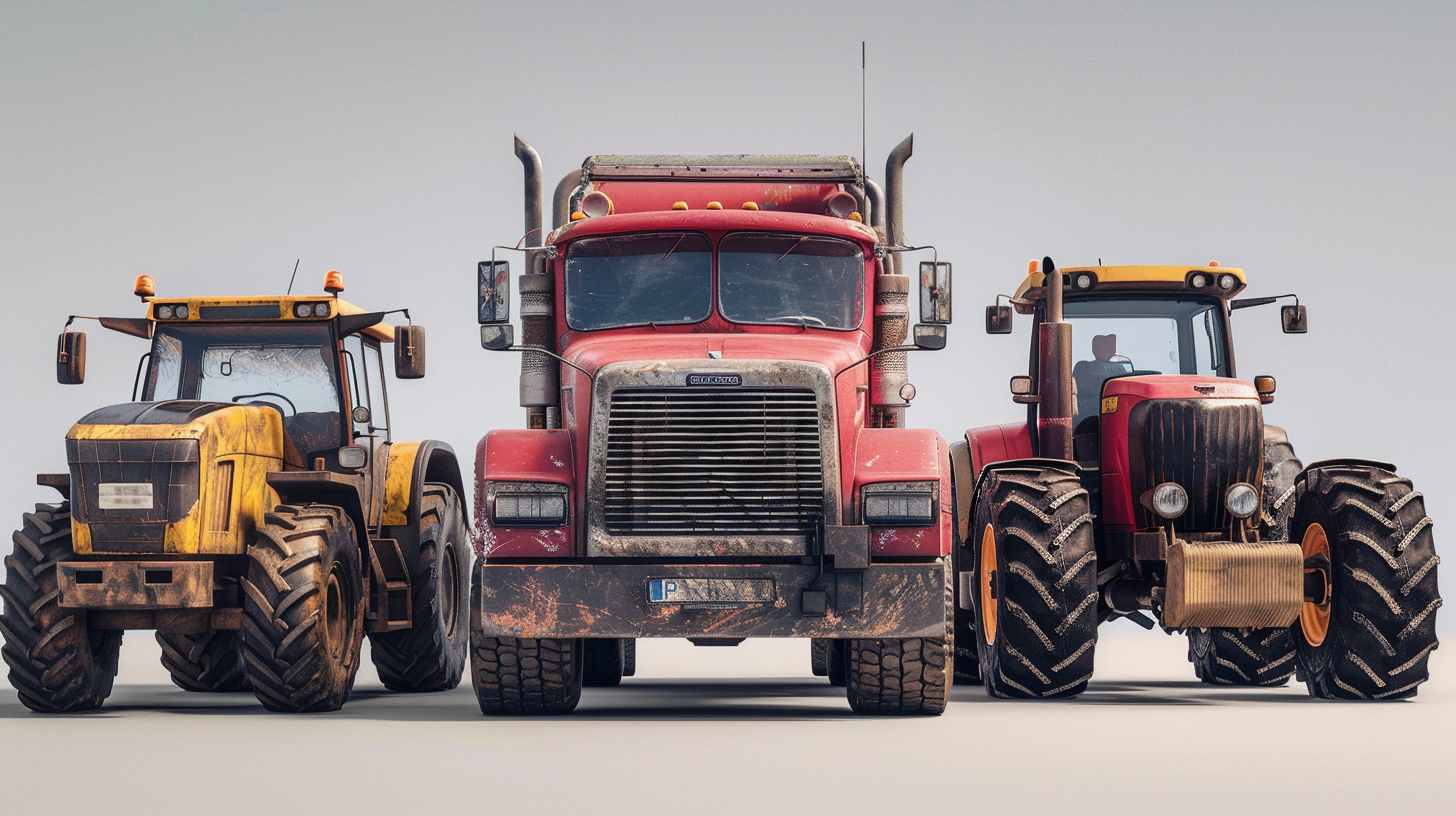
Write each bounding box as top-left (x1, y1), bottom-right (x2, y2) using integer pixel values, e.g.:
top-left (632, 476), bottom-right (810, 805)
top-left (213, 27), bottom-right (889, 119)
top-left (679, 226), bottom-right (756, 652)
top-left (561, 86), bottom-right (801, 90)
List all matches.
top-left (470, 570), bottom-right (584, 715)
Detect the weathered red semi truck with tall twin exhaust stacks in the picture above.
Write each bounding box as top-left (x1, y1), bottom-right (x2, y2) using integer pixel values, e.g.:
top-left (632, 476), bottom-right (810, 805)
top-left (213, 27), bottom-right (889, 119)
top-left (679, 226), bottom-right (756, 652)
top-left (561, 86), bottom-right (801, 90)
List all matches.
top-left (470, 138), bottom-right (952, 714)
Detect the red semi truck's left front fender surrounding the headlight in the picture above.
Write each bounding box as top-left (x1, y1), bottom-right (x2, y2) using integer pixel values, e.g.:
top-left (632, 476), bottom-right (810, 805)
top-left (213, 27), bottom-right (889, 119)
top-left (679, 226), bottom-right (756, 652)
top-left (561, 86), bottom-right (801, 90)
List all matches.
top-left (475, 428), bottom-right (570, 558)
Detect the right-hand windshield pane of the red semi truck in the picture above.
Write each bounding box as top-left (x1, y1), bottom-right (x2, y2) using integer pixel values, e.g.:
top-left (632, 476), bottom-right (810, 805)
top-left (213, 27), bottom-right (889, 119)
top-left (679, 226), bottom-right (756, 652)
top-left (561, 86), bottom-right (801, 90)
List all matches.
top-left (718, 232), bottom-right (865, 329)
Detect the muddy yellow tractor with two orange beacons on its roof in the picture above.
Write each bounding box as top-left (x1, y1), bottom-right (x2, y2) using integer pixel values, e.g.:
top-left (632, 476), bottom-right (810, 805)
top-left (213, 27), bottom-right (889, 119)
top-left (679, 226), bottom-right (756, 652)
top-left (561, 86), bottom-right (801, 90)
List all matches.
top-left (0, 272), bottom-right (472, 711)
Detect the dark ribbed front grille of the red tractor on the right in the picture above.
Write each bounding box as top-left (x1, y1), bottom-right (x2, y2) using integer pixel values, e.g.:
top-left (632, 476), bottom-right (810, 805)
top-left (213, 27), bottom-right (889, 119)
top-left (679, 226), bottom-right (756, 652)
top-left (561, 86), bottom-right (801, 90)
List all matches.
top-left (1128, 399), bottom-right (1264, 532)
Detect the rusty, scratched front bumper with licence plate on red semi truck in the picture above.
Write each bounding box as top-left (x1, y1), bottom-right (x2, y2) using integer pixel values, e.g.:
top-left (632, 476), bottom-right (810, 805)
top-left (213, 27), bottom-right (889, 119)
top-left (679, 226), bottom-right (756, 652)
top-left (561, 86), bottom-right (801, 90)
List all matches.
top-left (475, 561), bottom-right (946, 638)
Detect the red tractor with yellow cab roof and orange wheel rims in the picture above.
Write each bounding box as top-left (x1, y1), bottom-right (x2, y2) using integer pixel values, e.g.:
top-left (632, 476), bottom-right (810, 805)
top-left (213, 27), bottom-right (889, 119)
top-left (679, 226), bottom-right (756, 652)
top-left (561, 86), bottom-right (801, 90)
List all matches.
top-left (951, 258), bottom-right (1441, 699)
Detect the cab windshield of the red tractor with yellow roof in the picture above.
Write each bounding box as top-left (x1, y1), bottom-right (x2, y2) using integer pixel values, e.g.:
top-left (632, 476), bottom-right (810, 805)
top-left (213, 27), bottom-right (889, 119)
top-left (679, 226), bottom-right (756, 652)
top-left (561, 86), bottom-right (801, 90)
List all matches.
top-left (1063, 297), bottom-right (1233, 423)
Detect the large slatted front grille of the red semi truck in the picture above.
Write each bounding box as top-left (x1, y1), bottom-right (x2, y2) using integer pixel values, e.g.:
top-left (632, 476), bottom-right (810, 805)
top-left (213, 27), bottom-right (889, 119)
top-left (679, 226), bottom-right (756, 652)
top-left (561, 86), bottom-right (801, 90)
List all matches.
top-left (604, 388), bottom-right (824, 535)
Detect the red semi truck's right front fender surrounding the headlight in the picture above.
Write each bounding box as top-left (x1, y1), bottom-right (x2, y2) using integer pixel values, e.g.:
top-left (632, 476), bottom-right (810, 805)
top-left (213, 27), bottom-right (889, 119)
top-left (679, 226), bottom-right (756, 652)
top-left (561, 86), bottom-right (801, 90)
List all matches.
top-left (846, 428), bottom-right (954, 557)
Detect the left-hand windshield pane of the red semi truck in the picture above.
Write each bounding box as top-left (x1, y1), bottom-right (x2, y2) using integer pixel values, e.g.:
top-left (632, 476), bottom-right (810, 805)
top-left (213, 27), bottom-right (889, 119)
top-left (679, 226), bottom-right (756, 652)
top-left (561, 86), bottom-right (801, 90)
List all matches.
top-left (566, 232), bottom-right (713, 331)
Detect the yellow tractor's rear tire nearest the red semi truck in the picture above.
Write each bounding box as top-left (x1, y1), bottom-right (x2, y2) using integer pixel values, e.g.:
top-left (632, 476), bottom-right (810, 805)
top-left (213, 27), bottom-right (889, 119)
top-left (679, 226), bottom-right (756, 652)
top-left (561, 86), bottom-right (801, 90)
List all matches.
top-left (368, 484), bottom-right (470, 692)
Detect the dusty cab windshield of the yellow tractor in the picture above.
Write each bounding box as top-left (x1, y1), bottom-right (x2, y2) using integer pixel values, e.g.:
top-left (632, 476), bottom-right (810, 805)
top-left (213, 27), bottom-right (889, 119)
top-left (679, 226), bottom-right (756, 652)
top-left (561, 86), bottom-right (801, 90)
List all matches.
top-left (143, 323), bottom-right (344, 456)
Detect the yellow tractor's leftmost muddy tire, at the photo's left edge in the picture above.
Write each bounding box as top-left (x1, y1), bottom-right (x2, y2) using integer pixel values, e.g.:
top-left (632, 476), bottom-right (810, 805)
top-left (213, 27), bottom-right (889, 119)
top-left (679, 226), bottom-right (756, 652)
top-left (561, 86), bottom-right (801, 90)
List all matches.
top-left (0, 503), bottom-right (121, 714)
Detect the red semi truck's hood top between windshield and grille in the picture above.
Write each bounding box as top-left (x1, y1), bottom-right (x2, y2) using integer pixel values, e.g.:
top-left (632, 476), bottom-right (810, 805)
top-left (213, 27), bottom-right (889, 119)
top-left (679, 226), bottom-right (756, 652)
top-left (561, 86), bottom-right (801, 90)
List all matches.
top-left (562, 331), bottom-right (869, 374)
